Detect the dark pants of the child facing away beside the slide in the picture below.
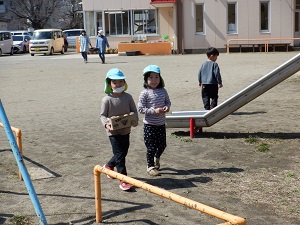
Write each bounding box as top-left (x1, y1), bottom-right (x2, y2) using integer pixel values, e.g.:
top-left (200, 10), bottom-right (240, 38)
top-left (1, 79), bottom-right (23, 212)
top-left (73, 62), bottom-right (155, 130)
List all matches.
top-left (202, 84), bottom-right (219, 110)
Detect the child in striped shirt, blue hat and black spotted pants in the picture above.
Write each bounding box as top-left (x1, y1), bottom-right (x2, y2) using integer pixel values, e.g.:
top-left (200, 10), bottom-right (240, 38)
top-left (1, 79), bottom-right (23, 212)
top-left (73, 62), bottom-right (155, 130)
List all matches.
top-left (138, 65), bottom-right (171, 176)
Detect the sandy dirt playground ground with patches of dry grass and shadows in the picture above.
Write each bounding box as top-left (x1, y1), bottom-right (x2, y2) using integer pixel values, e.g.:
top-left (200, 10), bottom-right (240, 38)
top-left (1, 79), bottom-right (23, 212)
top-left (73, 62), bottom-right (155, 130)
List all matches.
top-left (0, 52), bottom-right (300, 225)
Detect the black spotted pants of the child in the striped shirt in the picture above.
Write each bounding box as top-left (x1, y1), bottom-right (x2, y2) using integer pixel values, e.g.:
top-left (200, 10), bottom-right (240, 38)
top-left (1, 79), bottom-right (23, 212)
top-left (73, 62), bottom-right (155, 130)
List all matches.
top-left (144, 124), bottom-right (167, 168)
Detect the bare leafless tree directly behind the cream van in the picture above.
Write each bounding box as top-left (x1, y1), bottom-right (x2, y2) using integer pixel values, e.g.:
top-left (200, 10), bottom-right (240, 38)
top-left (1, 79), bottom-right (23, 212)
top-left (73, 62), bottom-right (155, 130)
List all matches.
top-left (9, 0), bottom-right (65, 29)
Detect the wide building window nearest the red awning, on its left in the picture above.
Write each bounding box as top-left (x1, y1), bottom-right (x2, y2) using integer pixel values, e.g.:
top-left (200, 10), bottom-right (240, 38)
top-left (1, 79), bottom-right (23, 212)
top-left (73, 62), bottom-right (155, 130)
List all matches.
top-left (132, 10), bottom-right (157, 34)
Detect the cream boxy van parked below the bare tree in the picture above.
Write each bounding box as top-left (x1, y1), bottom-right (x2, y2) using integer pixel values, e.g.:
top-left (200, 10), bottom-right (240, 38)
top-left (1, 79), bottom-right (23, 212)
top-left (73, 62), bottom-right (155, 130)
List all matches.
top-left (29, 29), bottom-right (65, 56)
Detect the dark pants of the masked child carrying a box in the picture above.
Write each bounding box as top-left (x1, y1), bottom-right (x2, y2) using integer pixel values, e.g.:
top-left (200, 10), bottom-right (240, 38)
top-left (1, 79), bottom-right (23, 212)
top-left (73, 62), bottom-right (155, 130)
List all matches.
top-left (107, 134), bottom-right (129, 175)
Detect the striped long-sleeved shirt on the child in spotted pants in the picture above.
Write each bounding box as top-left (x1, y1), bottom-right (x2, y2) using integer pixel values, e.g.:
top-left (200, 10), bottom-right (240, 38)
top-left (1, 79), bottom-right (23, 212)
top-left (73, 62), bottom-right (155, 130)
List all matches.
top-left (138, 88), bottom-right (171, 126)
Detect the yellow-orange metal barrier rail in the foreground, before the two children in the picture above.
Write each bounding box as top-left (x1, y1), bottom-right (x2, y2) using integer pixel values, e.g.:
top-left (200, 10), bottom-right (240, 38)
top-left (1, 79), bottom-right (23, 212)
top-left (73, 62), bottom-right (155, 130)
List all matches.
top-left (94, 165), bottom-right (246, 225)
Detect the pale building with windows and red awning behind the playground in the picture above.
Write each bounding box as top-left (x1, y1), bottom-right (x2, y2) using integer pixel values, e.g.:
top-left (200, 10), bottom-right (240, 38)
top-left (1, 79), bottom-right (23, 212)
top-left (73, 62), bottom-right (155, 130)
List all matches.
top-left (82, 0), bottom-right (300, 53)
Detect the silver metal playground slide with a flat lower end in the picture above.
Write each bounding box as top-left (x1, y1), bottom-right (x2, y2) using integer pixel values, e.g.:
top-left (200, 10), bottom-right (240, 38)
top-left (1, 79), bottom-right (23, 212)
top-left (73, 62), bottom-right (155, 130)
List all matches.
top-left (166, 51), bottom-right (300, 128)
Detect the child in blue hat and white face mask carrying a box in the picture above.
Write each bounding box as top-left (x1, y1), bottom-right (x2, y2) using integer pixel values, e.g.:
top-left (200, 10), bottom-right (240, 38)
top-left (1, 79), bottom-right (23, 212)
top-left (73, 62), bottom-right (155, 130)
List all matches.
top-left (100, 68), bottom-right (138, 191)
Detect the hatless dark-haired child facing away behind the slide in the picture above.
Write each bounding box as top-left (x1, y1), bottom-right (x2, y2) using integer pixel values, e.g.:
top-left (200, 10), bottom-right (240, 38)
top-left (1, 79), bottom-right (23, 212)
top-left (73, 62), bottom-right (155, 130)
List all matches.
top-left (198, 47), bottom-right (223, 110)
